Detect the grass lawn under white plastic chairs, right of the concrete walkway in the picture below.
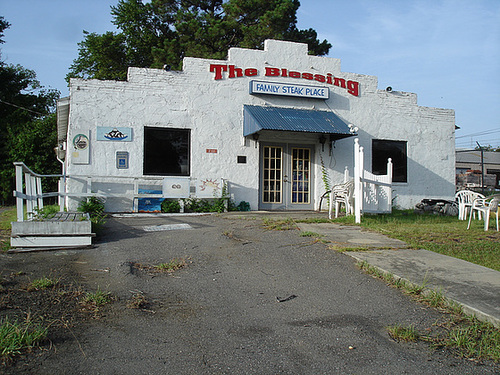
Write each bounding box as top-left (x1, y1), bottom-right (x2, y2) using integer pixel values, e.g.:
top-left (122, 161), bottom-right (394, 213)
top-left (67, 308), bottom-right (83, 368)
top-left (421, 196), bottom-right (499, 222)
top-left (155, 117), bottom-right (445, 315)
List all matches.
top-left (332, 211), bottom-right (500, 271)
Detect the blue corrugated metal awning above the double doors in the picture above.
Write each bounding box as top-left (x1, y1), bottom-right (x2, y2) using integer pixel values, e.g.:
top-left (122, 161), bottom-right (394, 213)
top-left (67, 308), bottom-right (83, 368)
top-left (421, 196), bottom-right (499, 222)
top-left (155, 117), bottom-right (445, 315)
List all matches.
top-left (243, 105), bottom-right (354, 139)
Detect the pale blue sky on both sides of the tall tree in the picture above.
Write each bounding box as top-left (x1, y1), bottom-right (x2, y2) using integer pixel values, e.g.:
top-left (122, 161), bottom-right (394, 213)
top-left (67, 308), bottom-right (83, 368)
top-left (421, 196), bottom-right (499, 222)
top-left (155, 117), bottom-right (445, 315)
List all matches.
top-left (0, 0), bottom-right (500, 148)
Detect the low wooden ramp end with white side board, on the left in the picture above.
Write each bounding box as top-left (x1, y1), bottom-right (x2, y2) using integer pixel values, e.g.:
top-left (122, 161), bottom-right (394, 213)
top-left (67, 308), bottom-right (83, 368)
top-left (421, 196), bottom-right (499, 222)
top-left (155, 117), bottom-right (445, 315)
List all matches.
top-left (9, 212), bottom-right (95, 252)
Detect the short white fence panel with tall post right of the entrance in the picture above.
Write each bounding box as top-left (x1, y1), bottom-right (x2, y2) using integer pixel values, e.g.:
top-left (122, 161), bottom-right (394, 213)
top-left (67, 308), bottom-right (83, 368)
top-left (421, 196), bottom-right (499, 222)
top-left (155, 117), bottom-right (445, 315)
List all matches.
top-left (354, 138), bottom-right (393, 223)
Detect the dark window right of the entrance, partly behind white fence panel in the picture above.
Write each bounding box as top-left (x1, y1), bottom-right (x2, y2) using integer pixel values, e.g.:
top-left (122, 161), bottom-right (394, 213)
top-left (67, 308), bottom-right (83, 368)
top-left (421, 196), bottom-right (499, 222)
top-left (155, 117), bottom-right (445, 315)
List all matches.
top-left (372, 139), bottom-right (408, 182)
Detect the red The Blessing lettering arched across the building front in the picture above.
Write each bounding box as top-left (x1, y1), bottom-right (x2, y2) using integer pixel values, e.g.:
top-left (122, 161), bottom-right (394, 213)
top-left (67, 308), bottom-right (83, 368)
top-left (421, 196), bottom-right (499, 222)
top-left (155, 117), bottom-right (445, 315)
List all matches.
top-left (210, 64), bottom-right (359, 96)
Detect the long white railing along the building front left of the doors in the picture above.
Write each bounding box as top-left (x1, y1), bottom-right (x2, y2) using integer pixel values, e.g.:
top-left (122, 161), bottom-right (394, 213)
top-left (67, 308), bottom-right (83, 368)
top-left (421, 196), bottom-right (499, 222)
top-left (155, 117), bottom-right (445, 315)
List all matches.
top-left (14, 162), bottom-right (228, 221)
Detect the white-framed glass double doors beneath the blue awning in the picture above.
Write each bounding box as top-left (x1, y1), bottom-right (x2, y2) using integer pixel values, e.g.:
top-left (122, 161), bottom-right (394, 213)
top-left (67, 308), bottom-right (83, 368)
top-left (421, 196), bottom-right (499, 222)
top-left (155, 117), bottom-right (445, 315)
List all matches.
top-left (259, 144), bottom-right (313, 210)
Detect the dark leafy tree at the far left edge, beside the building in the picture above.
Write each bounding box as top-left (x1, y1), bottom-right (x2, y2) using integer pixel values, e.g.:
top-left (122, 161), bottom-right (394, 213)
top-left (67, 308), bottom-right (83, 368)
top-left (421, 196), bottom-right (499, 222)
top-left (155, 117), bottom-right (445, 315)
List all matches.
top-left (0, 17), bottom-right (60, 203)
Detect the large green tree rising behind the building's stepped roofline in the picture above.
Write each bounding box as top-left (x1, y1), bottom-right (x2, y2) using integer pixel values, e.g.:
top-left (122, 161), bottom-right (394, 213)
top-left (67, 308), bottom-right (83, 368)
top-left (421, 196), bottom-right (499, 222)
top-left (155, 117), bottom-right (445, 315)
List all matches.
top-left (67, 0), bottom-right (331, 80)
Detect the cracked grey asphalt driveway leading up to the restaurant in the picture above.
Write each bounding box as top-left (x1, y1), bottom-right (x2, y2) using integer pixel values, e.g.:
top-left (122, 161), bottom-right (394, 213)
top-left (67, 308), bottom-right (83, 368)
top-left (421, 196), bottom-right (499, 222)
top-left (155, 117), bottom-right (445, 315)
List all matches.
top-left (4, 216), bottom-right (499, 374)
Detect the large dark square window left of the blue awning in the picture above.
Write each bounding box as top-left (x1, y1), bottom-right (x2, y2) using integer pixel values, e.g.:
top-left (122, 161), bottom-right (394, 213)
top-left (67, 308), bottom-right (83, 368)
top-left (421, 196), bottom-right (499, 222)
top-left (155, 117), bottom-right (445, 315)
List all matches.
top-left (143, 127), bottom-right (191, 176)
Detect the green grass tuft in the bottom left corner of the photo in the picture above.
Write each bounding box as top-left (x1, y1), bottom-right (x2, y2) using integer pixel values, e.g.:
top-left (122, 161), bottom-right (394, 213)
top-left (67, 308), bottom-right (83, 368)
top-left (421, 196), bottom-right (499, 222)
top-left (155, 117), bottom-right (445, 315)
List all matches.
top-left (0, 318), bottom-right (48, 359)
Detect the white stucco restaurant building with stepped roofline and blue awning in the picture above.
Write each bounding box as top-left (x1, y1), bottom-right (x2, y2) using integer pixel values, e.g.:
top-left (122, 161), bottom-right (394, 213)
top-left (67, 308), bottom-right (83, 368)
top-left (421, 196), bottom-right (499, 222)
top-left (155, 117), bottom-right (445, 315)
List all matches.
top-left (59, 40), bottom-right (455, 211)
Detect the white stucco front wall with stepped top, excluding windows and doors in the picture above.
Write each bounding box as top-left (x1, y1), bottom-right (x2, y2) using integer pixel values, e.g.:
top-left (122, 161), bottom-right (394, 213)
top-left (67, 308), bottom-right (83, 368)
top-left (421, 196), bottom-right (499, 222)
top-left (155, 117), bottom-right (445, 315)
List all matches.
top-left (66, 40), bottom-right (455, 211)
